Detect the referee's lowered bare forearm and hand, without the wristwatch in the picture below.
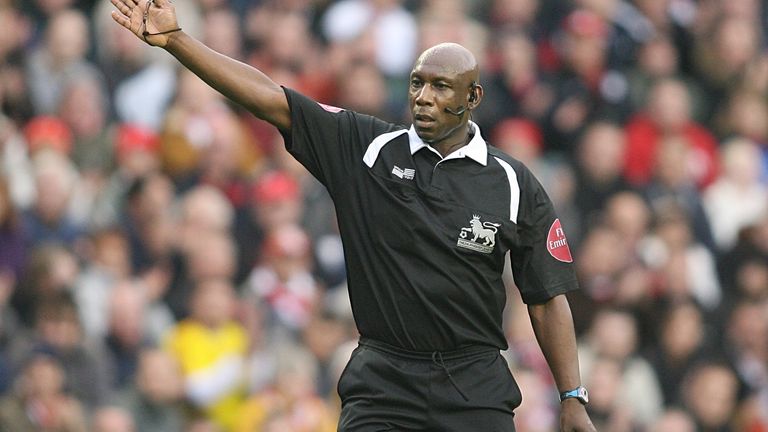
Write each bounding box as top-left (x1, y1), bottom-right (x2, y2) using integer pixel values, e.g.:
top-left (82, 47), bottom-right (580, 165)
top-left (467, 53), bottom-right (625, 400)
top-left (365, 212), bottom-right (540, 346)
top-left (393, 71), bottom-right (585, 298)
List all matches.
top-left (528, 294), bottom-right (595, 432)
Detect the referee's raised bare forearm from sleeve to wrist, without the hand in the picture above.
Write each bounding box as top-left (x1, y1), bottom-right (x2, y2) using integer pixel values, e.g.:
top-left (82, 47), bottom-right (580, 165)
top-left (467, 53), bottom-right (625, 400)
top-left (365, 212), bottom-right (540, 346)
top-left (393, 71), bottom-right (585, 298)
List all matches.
top-left (164, 31), bottom-right (291, 129)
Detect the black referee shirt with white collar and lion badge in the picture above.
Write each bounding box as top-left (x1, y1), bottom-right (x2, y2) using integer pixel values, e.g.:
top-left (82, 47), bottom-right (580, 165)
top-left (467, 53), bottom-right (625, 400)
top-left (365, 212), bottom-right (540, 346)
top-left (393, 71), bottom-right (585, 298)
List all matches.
top-left (282, 89), bottom-right (577, 351)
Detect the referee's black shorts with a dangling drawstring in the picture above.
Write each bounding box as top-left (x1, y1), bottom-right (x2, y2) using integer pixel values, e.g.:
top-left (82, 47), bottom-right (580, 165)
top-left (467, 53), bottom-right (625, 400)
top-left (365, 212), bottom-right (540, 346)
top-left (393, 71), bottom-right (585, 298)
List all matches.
top-left (338, 339), bottom-right (522, 432)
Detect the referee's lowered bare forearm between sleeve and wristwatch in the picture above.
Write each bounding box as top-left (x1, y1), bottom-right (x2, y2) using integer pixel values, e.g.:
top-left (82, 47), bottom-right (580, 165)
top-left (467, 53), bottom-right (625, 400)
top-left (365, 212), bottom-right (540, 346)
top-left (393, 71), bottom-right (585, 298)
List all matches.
top-left (528, 295), bottom-right (581, 392)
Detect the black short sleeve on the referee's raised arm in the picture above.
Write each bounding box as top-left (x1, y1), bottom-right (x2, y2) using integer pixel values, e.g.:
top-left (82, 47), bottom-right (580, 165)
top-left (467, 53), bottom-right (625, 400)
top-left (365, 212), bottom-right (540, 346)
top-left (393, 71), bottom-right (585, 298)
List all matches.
top-left (280, 89), bottom-right (396, 195)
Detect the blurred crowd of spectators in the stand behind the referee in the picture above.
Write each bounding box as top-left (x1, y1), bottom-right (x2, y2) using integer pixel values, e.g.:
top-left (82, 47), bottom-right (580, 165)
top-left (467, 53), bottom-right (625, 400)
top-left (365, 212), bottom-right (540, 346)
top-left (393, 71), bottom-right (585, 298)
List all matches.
top-left (0, 0), bottom-right (768, 432)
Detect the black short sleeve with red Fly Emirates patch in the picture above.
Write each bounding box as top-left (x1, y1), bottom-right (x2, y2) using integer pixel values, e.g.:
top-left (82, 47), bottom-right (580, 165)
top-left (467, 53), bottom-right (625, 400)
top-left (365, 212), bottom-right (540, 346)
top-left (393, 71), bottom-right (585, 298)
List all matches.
top-left (510, 165), bottom-right (578, 304)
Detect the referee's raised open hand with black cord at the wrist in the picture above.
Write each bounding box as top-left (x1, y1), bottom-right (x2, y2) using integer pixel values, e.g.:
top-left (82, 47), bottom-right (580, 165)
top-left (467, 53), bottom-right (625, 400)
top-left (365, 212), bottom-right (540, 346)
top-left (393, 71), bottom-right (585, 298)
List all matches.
top-left (111, 0), bottom-right (181, 47)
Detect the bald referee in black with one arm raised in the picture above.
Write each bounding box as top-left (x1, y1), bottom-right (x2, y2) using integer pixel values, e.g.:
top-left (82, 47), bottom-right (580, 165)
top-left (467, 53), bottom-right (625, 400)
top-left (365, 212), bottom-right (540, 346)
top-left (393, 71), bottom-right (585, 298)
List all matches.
top-left (112, 0), bottom-right (594, 432)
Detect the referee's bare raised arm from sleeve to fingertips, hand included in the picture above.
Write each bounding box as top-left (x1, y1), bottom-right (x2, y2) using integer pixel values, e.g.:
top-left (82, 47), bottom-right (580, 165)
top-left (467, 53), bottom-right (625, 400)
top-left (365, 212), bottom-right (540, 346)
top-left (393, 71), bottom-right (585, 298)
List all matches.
top-left (111, 0), bottom-right (291, 130)
